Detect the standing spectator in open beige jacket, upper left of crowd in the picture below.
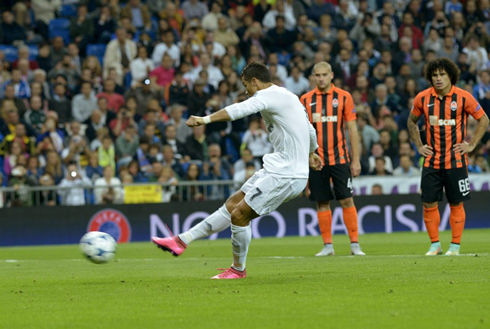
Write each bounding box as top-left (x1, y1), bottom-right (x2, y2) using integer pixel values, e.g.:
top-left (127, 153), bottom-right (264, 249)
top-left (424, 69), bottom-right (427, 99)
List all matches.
top-left (104, 27), bottom-right (137, 84)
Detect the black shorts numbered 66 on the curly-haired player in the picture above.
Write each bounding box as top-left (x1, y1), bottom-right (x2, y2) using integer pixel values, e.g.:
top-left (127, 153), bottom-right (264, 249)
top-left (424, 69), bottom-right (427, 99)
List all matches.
top-left (420, 167), bottom-right (471, 204)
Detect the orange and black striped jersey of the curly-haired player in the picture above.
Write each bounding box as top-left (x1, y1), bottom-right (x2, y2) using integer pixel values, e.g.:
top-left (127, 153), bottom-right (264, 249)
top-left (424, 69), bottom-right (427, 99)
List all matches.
top-left (412, 86), bottom-right (485, 169)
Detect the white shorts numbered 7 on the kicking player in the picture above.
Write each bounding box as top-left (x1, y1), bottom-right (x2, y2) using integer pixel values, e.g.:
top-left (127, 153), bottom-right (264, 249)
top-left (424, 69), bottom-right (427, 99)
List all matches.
top-left (241, 169), bottom-right (308, 216)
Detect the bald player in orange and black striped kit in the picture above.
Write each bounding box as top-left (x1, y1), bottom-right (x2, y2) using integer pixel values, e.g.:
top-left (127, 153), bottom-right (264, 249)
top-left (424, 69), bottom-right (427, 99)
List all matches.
top-left (301, 62), bottom-right (365, 256)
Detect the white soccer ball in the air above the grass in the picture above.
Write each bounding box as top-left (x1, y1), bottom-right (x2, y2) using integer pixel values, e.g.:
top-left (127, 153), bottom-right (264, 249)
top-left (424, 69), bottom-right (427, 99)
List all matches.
top-left (80, 231), bottom-right (117, 264)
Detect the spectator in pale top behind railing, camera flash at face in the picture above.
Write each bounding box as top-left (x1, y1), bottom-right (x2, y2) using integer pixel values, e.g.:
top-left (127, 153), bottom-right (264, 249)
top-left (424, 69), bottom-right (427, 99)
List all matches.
top-left (58, 162), bottom-right (92, 206)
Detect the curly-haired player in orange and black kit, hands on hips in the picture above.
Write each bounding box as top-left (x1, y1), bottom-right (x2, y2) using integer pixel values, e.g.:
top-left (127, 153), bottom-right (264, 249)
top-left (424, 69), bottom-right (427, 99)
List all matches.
top-left (408, 58), bottom-right (488, 256)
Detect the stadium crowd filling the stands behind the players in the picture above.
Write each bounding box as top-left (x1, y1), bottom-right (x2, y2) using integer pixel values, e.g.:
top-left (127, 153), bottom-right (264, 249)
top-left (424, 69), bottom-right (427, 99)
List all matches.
top-left (0, 0), bottom-right (490, 205)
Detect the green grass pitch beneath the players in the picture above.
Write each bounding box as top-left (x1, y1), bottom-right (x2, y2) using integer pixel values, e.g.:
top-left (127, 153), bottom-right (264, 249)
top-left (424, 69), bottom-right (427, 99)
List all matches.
top-left (0, 230), bottom-right (490, 329)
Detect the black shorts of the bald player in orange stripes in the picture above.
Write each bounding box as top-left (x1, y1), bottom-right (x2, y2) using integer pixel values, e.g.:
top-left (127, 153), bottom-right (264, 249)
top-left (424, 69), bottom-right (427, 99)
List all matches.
top-left (308, 164), bottom-right (353, 202)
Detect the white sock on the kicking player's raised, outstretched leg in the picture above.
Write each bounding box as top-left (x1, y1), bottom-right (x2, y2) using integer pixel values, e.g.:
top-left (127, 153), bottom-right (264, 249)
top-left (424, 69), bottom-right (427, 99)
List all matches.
top-left (179, 205), bottom-right (231, 245)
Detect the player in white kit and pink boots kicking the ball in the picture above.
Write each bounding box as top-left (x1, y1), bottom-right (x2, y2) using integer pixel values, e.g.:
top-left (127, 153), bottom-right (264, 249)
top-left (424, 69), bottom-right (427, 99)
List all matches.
top-left (152, 63), bottom-right (322, 279)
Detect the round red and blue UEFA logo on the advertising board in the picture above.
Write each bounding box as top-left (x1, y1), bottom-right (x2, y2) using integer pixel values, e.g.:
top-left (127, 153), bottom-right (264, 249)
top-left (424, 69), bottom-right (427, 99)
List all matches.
top-left (87, 209), bottom-right (131, 243)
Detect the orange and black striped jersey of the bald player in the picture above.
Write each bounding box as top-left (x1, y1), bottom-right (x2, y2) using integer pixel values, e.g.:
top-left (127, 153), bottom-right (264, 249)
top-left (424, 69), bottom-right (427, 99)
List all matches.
top-left (300, 84), bottom-right (356, 166)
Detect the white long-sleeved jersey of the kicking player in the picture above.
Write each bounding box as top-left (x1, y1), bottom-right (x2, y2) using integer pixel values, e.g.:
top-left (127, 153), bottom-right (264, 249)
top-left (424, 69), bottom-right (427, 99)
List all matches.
top-left (225, 85), bottom-right (318, 178)
